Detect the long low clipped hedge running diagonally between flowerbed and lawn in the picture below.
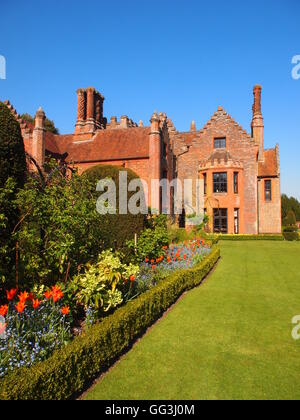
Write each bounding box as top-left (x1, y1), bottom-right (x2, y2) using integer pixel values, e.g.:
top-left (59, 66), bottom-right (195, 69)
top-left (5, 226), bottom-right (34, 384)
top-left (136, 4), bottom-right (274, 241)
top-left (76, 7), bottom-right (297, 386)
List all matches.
top-left (0, 247), bottom-right (220, 400)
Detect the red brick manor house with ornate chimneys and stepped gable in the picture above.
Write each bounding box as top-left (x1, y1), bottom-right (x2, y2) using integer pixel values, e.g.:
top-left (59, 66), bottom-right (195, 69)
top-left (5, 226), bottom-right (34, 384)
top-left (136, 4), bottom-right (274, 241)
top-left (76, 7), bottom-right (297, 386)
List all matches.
top-left (6, 86), bottom-right (281, 234)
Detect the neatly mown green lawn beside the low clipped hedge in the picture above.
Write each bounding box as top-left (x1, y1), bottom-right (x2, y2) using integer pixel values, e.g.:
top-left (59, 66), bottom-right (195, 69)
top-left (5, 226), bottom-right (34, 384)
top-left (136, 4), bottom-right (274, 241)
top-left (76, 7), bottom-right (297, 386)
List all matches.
top-left (86, 241), bottom-right (300, 400)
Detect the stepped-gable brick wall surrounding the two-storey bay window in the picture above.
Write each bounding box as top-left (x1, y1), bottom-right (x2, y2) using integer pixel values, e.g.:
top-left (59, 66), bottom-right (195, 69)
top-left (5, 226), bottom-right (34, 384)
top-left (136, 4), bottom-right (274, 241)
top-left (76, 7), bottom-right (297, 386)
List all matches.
top-left (175, 108), bottom-right (258, 234)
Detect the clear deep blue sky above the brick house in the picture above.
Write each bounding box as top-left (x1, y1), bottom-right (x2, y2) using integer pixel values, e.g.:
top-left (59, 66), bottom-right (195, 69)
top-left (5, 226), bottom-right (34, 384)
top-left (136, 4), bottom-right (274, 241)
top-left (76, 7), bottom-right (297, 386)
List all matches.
top-left (0, 0), bottom-right (300, 199)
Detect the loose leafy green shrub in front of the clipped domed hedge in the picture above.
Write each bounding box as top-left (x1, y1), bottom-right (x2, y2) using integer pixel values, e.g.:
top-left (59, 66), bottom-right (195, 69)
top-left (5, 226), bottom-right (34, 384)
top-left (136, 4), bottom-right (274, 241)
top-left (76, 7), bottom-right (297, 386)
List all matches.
top-left (14, 162), bottom-right (104, 287)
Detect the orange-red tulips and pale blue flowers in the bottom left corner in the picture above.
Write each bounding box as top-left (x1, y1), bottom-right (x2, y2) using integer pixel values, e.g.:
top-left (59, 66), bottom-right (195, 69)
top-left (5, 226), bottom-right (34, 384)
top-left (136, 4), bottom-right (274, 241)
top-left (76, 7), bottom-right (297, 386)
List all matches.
top-left (0, 286), bottom-right (71, 378)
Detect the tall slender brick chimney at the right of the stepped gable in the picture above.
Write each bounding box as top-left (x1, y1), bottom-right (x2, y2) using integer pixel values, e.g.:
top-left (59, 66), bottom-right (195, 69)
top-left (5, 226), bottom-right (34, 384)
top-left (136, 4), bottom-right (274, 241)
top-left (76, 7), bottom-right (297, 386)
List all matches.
top-left (251, 85), bottom-right (264, 162)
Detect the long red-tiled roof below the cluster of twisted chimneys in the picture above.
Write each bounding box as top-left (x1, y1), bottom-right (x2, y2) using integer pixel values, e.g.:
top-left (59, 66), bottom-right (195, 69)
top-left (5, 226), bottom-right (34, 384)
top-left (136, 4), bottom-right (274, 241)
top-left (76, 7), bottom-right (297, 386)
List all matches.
top-left (46, 127), bottom-right (150, 163)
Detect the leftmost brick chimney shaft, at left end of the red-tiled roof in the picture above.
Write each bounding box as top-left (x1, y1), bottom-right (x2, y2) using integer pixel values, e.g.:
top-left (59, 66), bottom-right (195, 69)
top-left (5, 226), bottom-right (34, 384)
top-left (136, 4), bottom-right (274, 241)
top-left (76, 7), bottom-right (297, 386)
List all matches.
top-left (32, 108), bottom-right (46, 169)
